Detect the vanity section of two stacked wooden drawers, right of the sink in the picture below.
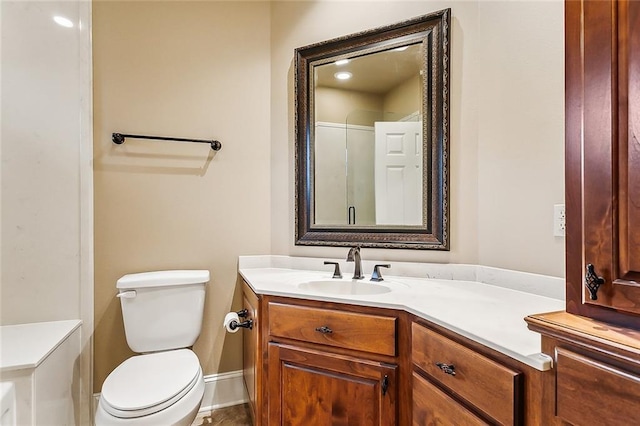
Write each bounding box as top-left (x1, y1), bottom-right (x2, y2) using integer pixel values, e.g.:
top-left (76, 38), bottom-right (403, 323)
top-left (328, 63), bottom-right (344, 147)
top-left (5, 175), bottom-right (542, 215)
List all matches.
top-left (411, 322), bottom-right (524, 425)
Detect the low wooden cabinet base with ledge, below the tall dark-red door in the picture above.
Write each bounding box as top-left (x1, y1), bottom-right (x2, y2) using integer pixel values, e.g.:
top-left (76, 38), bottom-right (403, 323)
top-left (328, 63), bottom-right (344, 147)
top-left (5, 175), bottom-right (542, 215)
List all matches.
top-left (527, 312), bottom-right (640, 426)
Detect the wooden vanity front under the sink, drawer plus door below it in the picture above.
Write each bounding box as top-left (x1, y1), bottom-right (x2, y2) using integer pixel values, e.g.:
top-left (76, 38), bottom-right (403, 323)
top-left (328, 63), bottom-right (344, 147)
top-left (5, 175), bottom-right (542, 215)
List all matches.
top-left (265, 297), bottom-right (400, 426)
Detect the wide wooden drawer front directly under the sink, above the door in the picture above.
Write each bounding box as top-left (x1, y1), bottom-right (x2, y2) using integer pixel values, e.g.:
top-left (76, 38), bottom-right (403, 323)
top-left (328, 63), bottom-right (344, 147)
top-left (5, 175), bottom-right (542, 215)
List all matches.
top-left (269, 302), bottom-right (396, 356)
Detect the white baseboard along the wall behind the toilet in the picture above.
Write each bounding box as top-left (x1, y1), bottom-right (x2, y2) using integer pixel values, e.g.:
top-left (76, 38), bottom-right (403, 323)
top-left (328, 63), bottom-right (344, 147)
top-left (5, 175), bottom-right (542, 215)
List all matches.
top-left (93, 370), bottom-right (249, 413)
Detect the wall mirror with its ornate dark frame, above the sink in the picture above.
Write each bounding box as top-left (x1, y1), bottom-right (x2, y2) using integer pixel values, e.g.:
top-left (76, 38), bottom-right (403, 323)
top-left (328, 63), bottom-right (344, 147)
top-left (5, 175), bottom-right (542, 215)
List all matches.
top-left (295, 9), bottom-right (450, 250)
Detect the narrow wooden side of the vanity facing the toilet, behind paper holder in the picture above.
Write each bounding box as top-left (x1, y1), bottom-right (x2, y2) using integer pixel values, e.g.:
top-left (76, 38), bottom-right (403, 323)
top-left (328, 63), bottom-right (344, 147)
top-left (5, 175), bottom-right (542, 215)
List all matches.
top-left (242, 284), bottom-right (262, 425)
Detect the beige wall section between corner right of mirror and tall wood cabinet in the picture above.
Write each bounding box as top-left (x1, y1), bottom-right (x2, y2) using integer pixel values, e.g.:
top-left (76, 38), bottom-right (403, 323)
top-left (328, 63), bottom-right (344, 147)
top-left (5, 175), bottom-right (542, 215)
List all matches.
top-left (477, 1), bottom-right (570, 276)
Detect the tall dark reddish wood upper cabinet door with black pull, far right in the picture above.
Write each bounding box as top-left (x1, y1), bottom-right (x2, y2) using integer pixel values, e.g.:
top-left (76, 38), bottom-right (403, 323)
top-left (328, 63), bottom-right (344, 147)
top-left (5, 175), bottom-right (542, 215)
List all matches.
top-left (565, 0), bottom-right (640, 327)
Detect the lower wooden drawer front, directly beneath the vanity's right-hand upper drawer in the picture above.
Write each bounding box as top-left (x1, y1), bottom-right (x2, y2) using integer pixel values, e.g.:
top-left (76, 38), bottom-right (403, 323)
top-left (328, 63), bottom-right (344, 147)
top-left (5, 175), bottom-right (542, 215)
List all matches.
top-left (413, 371), bottom-right (488, 426)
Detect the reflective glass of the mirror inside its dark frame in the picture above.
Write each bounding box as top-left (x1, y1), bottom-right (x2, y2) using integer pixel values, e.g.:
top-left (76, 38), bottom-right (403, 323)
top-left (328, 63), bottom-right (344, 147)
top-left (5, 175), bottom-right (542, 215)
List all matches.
top-left (313, 43), bottom-right (424, 226)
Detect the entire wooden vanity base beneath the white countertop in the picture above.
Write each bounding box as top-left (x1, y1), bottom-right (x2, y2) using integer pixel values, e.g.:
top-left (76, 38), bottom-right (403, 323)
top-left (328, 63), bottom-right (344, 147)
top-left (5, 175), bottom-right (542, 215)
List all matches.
top-left (243, 283), bottom-right (554, 426)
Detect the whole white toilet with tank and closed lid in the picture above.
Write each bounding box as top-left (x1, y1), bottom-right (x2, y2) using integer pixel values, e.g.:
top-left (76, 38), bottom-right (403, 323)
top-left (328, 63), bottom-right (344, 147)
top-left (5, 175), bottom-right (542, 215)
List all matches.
top-left (95, 270), bottom-right (209, 426)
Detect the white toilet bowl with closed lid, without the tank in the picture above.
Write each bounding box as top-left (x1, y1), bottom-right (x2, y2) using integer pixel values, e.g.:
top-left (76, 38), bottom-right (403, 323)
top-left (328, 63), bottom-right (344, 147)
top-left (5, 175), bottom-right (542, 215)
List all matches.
top-left (95, 349), bottom-right (204, 426)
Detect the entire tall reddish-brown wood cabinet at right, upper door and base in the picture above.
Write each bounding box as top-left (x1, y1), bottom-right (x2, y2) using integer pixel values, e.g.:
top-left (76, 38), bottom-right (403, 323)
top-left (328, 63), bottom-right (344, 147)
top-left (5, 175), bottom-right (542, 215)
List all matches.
top-left (526, 0), bottom-right (640, 426)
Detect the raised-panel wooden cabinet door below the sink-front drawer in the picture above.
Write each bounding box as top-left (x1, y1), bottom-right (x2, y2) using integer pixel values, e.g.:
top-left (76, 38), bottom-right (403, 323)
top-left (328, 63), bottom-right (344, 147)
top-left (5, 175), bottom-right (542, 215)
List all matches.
top-left (269, 343), bottom-right (398, 426)
